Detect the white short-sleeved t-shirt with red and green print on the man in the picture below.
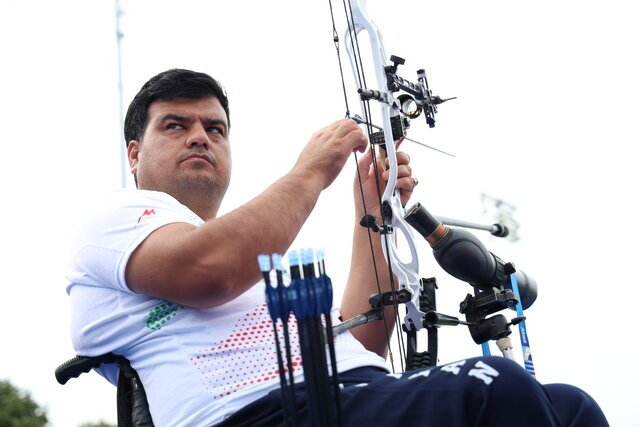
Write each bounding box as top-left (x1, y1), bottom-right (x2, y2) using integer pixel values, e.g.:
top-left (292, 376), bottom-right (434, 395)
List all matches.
top-left (66, 190), bottom-right (386, 426)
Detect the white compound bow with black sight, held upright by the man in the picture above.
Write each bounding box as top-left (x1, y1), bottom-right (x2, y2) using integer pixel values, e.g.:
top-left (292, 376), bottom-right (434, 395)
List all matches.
top-left (329, 0), bottom-right (446, 369)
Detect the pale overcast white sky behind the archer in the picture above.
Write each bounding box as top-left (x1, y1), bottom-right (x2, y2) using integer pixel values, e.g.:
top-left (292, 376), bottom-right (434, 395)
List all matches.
top-left (0, 0), bottom-right (640, 427)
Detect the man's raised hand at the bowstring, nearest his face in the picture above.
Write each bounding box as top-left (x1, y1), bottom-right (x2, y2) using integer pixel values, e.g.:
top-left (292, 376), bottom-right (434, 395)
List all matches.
top-left (293, 119), bottom-right (368, 190)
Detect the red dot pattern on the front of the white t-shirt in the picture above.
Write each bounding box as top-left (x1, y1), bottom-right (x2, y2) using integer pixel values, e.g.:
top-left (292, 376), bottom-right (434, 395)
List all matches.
top-left (191, 304), bottom-right (302, 399)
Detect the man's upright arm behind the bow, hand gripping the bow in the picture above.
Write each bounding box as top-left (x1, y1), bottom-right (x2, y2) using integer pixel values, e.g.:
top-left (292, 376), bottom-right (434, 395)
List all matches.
top-left (341, 152), bottom-right (414, 357)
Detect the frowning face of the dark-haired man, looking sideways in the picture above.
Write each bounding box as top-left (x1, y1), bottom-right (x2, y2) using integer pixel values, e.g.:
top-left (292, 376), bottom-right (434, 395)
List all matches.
top-left (128, 97), bottom-right (231, 204)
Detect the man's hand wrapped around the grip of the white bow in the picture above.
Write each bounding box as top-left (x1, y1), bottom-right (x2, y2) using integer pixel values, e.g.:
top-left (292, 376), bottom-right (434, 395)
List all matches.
top-left (353, 146), bottom-right (416, 223)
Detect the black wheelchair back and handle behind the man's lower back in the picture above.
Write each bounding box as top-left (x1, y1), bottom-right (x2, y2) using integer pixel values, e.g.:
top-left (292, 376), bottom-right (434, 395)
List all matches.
top-left (55, 353), bottom-right (153, 427)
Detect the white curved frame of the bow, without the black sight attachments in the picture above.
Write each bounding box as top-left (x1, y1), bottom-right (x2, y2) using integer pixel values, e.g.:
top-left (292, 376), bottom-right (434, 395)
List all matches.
top-left (344, 0), bottom-right (424, 329)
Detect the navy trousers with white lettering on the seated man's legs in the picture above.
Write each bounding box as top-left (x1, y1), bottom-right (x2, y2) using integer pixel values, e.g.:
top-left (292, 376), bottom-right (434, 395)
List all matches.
top-left (220, 357), bottom-right (609, 427)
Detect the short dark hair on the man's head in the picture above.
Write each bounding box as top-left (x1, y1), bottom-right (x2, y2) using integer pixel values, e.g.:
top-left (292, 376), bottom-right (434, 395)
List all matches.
top-left (124, 68), bottom-right (231, 146)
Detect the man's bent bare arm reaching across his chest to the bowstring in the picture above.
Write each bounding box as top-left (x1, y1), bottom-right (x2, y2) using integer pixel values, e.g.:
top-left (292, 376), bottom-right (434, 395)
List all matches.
top-left (125, 119), bottom-right (367, 307)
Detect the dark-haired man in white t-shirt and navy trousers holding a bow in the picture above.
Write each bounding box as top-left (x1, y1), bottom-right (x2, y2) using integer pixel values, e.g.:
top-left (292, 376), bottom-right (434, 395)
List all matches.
top-left (67, 70), bottom-right (606, 426)
